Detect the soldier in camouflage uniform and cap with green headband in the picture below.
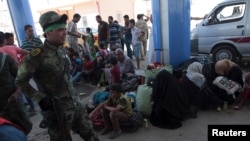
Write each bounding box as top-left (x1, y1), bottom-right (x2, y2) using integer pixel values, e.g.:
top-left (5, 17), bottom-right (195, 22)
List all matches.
top-left (16, 11), bottom-right (99, 141)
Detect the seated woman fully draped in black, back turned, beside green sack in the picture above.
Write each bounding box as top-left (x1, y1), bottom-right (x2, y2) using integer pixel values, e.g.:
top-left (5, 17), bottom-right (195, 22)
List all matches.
top-left (150, 70), bottom-right (191, 129)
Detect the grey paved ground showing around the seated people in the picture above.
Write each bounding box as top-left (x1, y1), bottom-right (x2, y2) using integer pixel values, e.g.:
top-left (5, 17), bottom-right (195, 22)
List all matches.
top-left (25, 56), bottom-right (250, 141)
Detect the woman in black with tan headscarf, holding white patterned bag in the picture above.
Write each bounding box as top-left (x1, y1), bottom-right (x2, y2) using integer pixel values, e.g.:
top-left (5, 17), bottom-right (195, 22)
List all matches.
top-left (202, 59), bottom-right (243, 111)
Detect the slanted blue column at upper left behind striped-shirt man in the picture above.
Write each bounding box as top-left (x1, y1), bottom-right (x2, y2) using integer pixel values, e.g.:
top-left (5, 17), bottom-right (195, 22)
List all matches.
top-left (7, 0), bottom-right (36, 45)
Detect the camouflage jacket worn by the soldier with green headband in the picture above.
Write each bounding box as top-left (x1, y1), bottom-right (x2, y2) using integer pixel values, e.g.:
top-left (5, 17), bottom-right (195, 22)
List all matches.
top-left (16, 41), bottom-right (74, 107)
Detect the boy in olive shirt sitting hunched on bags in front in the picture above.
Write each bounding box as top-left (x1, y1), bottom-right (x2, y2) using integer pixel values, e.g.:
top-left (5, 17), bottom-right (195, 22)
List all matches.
top-left (89, 83), bottom-right (133, 139)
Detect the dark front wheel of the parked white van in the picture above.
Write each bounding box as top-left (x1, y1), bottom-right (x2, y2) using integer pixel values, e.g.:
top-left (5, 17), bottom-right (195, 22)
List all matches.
top-left (212, 45), bottom-right (237, 62)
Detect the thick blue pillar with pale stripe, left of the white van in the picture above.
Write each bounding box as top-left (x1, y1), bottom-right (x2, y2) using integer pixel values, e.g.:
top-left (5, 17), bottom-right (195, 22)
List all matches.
top-left (152, 0), bottom-right (190, 67)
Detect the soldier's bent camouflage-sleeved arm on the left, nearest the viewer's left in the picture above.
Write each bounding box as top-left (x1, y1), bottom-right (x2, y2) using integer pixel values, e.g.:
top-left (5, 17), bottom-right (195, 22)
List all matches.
top-left (16, 56), bottom-right (44, 102)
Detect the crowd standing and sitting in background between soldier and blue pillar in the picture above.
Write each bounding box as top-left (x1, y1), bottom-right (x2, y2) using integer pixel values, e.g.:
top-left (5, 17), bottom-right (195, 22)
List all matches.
top-left (66, 13), bottom-right (152, 86)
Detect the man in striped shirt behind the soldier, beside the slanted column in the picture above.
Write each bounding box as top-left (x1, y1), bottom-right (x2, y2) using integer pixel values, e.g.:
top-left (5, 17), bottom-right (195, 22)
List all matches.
top-left (21, 25), bottom-right (43, 51)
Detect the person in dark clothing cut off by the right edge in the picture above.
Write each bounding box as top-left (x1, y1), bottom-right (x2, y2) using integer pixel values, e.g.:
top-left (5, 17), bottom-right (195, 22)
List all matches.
top-left (233, 74), bottom-right (250, 110)
